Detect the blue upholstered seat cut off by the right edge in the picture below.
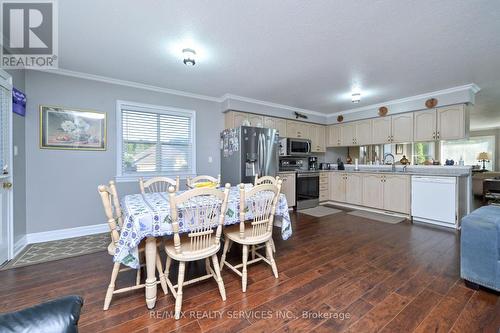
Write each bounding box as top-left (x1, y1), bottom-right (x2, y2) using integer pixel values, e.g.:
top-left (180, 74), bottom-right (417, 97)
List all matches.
top-left (460, 206), bottom-right (500, 291)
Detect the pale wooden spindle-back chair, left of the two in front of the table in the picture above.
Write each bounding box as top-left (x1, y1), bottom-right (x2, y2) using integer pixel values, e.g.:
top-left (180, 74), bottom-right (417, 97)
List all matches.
top-left (165, 184), bottom-right (231, 319)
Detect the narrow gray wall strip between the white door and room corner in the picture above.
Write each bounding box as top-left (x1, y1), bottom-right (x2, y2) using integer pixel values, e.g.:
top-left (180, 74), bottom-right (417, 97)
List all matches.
top-left (8, 69), bottom-right (26, 243)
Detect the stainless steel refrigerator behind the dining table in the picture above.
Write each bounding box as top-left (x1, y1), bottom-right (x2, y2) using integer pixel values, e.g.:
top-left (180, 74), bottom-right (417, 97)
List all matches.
top-left (220, 126), bottom-right (279, 185)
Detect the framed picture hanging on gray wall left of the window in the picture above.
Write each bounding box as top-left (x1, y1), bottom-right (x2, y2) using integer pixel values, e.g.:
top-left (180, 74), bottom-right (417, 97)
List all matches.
top-left (40, 105), bottom-right (106, 150)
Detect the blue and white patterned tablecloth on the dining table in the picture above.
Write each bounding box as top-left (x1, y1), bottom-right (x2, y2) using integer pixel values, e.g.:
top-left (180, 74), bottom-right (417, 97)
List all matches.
top-left (113, 187), bottom-right (292, 268)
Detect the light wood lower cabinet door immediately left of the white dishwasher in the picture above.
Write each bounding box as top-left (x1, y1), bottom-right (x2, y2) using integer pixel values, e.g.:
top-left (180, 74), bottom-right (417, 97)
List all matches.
top-left (383, 175), bottom-right (410, 214)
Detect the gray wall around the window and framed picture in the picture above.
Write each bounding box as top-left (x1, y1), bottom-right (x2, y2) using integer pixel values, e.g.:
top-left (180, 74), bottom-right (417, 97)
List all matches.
top-left (25, 71), bottom-right (224, 233)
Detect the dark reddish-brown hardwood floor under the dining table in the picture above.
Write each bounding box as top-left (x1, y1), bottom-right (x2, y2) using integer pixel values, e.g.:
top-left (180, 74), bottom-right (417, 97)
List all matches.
top-left (0, 213), bottom-right (500, 332)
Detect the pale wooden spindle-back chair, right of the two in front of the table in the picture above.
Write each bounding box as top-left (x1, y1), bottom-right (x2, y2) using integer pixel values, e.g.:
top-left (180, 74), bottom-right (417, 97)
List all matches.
top-left (221, 180), bottom-right (282, 292)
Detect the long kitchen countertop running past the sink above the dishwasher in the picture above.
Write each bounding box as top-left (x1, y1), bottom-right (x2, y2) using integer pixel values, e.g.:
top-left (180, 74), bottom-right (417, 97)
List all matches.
top-left (278, 164), bottom-right (471, 177)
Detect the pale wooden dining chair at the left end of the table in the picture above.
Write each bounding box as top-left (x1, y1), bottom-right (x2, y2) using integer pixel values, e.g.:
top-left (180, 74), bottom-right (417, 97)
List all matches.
top-left (98, 181), bottom-right (168, 310)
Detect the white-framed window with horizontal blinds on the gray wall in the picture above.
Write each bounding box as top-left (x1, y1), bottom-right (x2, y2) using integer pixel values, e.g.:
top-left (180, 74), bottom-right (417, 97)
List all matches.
top-left (117, 101), bottom-right (196, 178)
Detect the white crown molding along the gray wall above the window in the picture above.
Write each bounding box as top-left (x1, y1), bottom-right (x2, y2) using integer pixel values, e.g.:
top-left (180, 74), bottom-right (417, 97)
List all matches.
top-left (31, 68), bottom-right (222, 103)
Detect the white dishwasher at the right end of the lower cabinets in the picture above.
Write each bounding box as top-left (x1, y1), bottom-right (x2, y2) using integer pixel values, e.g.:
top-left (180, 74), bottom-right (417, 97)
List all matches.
top-left (411, 176), bottom-right (457, 228)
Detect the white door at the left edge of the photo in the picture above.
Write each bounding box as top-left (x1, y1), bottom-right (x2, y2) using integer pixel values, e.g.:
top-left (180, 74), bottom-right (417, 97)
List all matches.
top-left (0, 71), bottom-right (12, 265)
